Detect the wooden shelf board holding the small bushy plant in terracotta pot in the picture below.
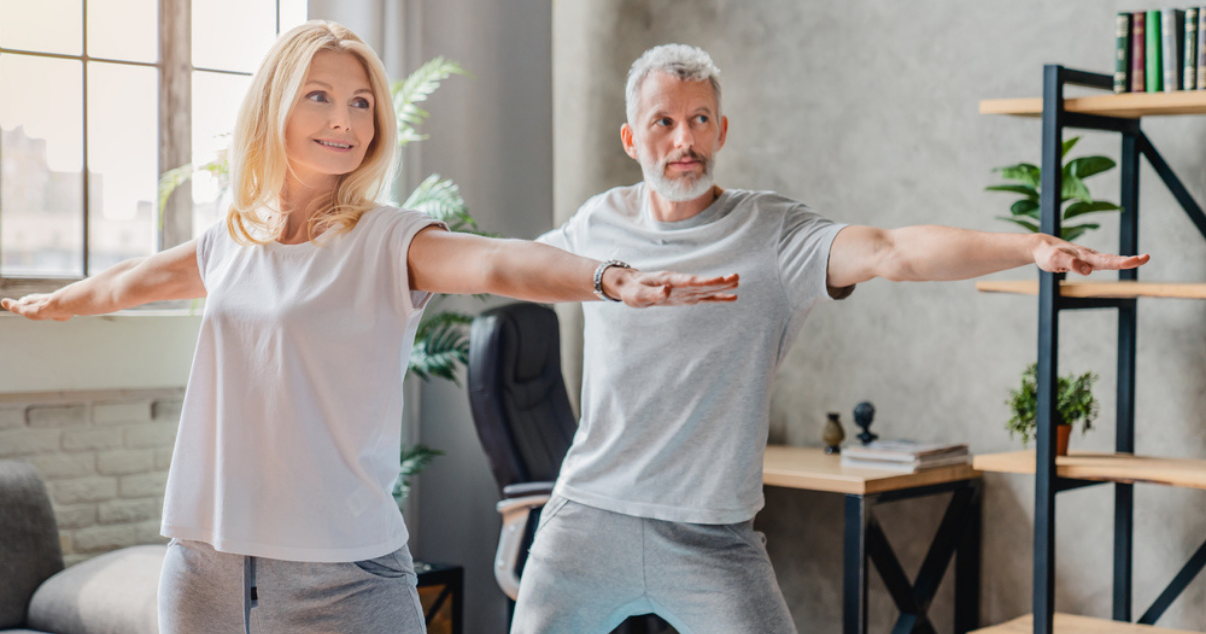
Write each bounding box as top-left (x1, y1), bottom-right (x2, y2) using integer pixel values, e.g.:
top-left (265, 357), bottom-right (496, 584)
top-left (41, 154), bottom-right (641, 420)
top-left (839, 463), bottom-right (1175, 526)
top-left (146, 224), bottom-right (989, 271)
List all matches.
top-left (973, 451), bottom-right (1206, 489)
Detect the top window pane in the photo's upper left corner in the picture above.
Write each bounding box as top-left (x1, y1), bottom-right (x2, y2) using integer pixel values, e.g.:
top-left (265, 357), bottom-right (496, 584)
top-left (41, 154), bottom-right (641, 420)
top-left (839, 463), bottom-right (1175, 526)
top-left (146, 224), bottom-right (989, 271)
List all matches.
top-left (0, 0), bottom-right (83, 55)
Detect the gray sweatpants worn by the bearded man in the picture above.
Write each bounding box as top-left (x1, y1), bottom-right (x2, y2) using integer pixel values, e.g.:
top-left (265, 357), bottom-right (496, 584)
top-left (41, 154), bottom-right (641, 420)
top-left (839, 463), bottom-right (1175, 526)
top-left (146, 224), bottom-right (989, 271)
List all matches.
top-left (511, 495), bottom-right (796, 634)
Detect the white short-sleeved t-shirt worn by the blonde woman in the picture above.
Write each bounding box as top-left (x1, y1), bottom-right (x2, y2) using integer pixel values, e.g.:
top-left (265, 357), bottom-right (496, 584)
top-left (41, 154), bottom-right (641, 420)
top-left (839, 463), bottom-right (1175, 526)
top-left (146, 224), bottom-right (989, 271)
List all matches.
top-left (162, 207), bottom-right (437, 562)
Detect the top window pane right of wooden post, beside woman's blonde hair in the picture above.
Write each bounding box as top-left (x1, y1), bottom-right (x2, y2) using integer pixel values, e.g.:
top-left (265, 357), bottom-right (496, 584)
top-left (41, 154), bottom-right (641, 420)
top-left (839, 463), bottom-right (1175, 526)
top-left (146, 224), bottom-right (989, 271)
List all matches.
top-left (193, 0), bottom-right (276, 72)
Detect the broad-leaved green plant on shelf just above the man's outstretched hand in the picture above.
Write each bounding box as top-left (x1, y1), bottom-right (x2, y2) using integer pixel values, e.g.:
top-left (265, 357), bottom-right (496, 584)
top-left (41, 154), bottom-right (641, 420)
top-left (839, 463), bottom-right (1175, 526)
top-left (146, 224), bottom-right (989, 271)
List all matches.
top-left (984, 136), bottom-right (1123, 241)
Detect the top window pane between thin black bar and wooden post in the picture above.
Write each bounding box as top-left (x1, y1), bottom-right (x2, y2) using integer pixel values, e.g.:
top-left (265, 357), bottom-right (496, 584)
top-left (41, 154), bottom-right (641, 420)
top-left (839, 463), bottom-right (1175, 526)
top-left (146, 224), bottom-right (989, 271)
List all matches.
top-left (88, 0), bottom-right (159, 64)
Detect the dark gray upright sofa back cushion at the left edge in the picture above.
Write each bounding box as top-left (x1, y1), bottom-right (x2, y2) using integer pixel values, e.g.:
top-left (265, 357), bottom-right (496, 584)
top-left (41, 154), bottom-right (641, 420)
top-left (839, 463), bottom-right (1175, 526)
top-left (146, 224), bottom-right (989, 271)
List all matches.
top-left (0, 460), bottom-right (63, 629)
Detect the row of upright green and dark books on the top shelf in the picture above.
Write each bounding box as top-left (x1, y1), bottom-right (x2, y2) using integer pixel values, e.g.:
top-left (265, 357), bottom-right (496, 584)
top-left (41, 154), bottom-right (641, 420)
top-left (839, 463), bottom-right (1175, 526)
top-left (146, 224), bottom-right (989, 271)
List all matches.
top-left (1114, 7), bottom-right (1206, 93)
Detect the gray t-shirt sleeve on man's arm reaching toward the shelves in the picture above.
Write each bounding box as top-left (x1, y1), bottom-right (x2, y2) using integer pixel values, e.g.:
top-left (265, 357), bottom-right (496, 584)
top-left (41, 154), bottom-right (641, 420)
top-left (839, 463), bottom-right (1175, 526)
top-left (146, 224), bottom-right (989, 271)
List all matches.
top-left (778, 204), bottom-right (854, 309)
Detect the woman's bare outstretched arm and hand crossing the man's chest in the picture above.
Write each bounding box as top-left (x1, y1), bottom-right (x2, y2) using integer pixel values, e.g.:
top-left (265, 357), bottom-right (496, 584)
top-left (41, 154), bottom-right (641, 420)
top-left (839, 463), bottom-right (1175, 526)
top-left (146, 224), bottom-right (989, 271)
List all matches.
top-left (408, 227), bottom-right (738, 307)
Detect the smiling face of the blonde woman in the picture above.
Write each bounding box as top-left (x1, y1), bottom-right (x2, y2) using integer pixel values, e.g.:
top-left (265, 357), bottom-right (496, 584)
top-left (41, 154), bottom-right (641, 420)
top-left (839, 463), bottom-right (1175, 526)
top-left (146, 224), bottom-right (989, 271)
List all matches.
top-left (285, 51), bottom-right (376, 188)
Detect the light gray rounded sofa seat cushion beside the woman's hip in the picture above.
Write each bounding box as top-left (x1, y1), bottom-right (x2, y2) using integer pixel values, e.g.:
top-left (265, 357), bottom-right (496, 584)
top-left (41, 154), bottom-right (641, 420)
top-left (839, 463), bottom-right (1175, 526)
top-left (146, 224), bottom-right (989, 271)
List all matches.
top-left (29, 546), bottom-right (168, 634)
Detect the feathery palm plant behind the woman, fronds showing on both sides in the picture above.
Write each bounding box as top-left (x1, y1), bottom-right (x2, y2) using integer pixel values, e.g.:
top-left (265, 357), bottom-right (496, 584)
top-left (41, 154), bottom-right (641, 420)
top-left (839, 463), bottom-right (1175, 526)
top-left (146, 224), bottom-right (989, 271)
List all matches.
top-left (158, 57), bottom-right (477, 506)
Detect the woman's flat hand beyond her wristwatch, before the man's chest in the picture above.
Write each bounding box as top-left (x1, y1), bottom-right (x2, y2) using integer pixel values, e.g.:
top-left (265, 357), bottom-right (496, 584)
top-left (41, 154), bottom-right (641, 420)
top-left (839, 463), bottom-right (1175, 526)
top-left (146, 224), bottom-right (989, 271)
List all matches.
top-left (603, 266), bottom-right (739, 309)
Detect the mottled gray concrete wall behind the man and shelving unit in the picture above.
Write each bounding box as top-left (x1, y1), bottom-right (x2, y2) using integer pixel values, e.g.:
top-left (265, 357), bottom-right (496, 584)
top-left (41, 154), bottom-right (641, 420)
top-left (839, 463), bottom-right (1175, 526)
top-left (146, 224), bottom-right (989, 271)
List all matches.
top-left (554, 0), bottom-right (1206, 632)
